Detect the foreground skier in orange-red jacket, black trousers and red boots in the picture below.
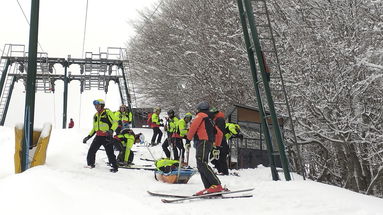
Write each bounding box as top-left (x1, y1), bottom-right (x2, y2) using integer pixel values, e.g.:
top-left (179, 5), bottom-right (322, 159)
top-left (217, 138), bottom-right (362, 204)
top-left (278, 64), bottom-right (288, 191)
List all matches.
top-left (187, 101), bottom-right (225, 195)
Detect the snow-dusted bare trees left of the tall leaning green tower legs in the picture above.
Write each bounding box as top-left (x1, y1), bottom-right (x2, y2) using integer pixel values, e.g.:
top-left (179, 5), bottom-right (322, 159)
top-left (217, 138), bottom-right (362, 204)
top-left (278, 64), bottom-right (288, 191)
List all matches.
top-left (129, 0), bottom-right (254, 111)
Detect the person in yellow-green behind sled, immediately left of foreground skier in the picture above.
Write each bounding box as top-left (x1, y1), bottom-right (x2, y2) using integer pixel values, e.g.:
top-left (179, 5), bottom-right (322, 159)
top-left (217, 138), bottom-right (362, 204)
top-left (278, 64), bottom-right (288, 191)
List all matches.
top-left (172, 113), bottom-right (193, 163)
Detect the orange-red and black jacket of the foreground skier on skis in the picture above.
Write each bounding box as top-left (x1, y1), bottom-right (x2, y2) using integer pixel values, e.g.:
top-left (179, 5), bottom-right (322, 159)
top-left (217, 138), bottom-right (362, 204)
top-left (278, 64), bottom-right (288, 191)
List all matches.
top-left (187, 112), bottom-right (223, 146)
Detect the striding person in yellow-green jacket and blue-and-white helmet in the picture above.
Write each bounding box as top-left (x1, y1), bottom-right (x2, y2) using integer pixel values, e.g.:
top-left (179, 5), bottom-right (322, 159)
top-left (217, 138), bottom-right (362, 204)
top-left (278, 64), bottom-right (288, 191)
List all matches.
top-left (83, 99), bottom-right (118, 172)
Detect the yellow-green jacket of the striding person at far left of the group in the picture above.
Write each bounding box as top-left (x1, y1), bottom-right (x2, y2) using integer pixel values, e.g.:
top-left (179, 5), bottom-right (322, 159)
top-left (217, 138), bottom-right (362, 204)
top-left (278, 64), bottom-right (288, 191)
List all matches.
top-left (89, 108), bottom-right (118, 136)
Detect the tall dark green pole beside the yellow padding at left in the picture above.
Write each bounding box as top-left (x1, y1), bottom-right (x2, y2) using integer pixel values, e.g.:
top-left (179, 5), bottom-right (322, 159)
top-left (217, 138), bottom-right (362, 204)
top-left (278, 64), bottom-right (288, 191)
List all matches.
top-left (21, 0), bottom-right (40, 172)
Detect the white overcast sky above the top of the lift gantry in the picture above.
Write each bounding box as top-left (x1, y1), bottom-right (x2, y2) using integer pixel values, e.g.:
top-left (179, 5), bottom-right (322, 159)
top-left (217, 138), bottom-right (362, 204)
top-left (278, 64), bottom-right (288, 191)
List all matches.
top-left (0, 0), bottom-right (158, 57)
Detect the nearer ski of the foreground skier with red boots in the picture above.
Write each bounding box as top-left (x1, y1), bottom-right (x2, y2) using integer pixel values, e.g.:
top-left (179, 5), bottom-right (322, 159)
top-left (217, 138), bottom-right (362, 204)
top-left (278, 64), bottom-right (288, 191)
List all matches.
top-left (161, 188), bottom-right (254, 203)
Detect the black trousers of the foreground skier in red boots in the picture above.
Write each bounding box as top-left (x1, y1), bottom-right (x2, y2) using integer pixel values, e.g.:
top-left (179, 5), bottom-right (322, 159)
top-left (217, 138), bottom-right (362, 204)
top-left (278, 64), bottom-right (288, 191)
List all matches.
top-left (196, 140), bottom-right (221, 189)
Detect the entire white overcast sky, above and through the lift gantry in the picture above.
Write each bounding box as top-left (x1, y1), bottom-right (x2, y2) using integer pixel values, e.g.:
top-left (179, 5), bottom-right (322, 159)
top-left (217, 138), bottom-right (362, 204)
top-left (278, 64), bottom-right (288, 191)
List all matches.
top-left (0, 0), bottom-right (159, 128)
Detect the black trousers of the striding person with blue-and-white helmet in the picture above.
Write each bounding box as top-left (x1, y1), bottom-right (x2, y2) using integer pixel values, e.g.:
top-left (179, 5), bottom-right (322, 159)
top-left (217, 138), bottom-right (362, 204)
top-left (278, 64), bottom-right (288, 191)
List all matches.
top-left (86, 136), bottom-right (118, 168)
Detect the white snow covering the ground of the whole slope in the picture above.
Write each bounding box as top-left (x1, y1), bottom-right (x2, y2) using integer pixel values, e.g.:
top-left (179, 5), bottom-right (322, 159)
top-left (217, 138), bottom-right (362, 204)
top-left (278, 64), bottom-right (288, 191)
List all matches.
top-left (0, 127), bottom-right (383, 215)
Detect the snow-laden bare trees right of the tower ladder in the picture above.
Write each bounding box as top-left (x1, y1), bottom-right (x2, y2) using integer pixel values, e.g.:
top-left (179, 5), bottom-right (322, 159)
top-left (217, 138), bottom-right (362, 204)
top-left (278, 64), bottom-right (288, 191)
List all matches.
top-left (273, 0), bottom-right (383, 195)
